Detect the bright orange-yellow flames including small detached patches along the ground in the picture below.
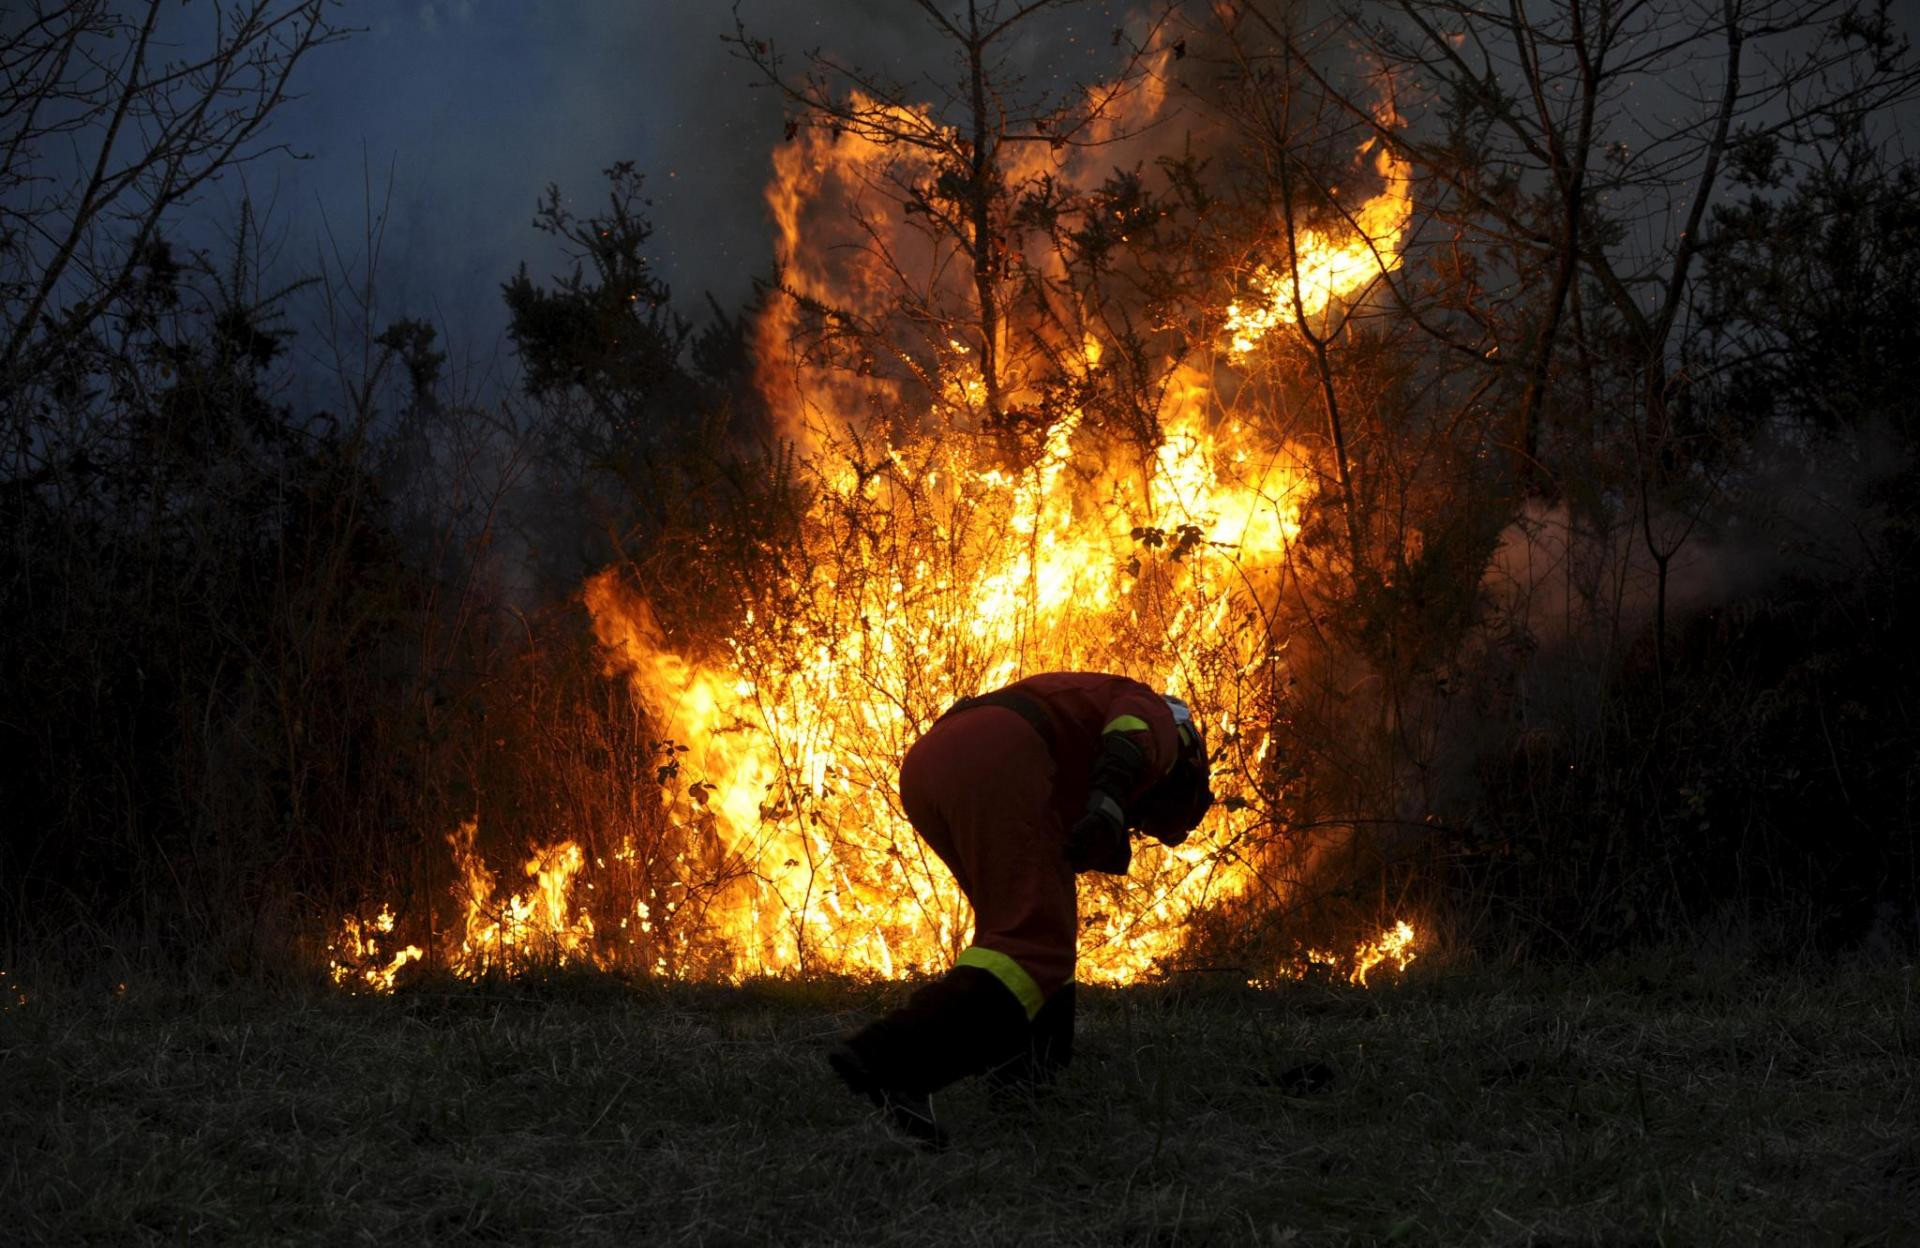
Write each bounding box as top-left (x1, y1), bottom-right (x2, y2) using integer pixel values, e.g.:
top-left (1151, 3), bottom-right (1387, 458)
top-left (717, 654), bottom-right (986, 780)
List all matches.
top-left (330, 51), bottom-right (1415, 991)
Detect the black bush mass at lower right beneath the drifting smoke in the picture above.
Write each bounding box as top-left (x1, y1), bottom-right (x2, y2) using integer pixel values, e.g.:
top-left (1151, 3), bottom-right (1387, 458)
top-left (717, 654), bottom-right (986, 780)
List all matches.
top-left (1452, 568), bottom-right (1920, 956)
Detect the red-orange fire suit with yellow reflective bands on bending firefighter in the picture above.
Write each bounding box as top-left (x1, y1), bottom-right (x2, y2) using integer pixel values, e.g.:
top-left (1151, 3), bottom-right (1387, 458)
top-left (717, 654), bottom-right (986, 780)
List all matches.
top-left (900, 672), bottom-right (1179, 1020)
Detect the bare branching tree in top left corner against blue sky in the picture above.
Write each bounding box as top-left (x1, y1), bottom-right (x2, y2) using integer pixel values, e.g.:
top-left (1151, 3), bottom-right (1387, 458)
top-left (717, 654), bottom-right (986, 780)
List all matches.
top-left (0, 0), bottom-right (344, 394)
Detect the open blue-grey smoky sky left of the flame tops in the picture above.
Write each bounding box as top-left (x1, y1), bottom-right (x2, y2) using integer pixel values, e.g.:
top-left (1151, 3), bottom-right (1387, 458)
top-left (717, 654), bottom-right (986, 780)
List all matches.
top-left (249, 0), bottom-right (1125, 387)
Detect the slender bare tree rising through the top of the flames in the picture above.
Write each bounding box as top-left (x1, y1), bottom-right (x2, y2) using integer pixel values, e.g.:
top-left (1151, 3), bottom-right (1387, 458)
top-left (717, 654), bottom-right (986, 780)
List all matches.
top-left (733, 0), bottom-right (1165, 455)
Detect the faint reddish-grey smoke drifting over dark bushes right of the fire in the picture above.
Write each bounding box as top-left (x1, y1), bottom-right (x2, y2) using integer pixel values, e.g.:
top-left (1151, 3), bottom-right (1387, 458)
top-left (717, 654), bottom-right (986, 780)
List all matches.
top-left (1428, 418), bottom-right (1907, 821)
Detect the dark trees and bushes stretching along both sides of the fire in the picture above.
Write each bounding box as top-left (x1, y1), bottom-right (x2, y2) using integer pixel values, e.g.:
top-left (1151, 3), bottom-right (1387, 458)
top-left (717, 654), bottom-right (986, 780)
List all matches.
top-left (0, 2), bottom-right (1920, 970)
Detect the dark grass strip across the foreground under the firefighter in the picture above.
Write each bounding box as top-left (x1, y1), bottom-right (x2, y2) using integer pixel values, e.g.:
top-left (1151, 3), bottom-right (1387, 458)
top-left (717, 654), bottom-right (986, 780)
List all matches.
top-left (0, 956), bottom-right (1920, 1244)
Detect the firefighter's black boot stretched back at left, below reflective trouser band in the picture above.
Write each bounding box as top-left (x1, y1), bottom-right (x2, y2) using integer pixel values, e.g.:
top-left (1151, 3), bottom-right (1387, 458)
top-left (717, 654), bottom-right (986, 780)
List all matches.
top-left (828, 966), bottom-right (1029, 1148)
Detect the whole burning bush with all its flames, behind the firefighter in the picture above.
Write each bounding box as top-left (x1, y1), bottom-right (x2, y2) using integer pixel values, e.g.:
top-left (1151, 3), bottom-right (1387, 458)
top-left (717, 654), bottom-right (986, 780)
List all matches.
top-left (334, 14), bottom-right (1413, 981)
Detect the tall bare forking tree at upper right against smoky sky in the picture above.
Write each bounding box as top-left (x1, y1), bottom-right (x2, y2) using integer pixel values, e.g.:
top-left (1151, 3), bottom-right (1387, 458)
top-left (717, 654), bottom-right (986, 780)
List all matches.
top-left (1205, 0), bottom-right (1920, 691)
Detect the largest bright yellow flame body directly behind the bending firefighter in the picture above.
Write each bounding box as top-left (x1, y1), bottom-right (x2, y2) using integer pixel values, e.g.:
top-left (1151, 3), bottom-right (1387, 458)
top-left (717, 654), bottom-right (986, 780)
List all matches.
top-left (588, 395), bottom-right (1304, 981)
